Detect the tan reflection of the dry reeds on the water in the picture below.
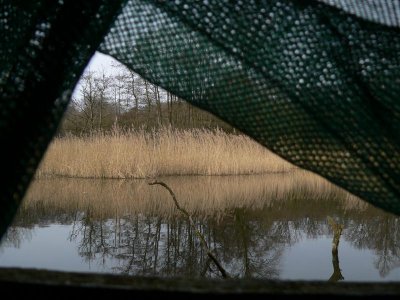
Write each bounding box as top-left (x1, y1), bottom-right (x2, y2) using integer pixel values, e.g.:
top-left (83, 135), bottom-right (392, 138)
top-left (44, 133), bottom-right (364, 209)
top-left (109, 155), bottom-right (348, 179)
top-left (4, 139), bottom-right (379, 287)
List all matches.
top-left (23, 170), bottom-right (367, 218)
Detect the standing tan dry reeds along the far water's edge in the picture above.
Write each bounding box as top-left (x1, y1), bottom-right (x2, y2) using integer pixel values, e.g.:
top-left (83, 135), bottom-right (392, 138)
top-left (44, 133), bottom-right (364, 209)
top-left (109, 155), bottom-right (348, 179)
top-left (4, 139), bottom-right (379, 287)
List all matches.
top-left (36, 128), bottom-right (294, 178)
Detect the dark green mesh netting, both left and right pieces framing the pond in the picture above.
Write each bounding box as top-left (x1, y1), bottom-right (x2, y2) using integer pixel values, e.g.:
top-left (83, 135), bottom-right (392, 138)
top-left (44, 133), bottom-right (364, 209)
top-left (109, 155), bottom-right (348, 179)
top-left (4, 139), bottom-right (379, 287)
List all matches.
top-left (0, 0), bottom-right (400, 241)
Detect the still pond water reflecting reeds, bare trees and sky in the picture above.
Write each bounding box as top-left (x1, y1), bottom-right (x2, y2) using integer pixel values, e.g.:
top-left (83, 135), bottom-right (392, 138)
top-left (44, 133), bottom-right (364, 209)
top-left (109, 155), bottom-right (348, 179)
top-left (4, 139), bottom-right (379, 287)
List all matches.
top-left (0, 171), bottom-right (400, 281)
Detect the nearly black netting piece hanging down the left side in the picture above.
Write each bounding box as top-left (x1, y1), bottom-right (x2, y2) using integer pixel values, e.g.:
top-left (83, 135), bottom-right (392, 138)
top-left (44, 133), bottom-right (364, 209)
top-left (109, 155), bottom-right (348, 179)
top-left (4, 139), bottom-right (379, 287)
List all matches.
top-left (0, 0), bottom-right (126, 237)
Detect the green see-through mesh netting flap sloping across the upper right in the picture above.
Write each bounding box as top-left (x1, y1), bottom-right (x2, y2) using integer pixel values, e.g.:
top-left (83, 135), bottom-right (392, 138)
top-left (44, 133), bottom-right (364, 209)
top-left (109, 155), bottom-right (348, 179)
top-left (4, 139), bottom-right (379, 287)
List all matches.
top-left (99, 0), bottom-right (400, 214)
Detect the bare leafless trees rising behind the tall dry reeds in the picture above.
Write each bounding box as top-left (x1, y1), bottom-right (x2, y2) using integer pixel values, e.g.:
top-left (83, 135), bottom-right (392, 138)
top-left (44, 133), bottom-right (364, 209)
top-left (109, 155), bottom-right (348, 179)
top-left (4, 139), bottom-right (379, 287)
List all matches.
top-left (59, 65), bottom-right (235, 134)
